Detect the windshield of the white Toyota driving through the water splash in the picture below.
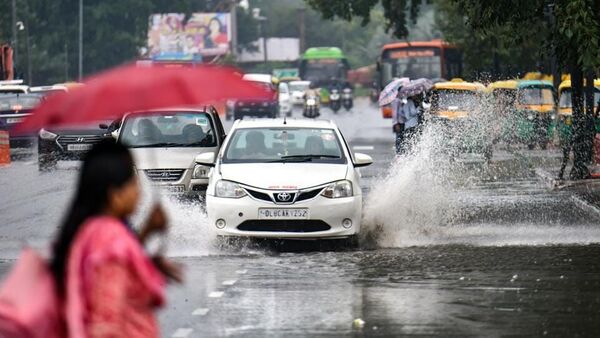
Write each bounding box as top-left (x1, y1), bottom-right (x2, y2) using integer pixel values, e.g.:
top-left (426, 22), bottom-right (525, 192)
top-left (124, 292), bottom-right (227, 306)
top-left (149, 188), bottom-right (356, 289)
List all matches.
top-left (223, 128), bottom-right (346, 164)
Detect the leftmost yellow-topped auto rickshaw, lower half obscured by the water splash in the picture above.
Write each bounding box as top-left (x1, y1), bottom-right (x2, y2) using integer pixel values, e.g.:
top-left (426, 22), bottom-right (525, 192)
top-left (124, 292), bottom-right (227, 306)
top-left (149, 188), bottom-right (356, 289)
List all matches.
top-left (428, 79), bottom-right (493, 160)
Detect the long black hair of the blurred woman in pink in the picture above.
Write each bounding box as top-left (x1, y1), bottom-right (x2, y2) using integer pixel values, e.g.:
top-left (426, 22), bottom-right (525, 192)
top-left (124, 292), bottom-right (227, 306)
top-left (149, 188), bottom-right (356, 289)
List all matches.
top-left (50, 140), bottom-right (134, 294)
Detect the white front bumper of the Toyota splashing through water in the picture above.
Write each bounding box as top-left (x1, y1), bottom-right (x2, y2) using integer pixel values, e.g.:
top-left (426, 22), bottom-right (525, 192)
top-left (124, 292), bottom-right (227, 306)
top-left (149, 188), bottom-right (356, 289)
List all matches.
top-left (206, 195), bottom-right (362, 239)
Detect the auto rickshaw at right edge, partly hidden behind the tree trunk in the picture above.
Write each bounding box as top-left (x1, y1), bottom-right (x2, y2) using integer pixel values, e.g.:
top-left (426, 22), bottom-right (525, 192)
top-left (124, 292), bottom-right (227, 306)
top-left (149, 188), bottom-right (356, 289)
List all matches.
top-left (557, 79), bottom-right (600, 145)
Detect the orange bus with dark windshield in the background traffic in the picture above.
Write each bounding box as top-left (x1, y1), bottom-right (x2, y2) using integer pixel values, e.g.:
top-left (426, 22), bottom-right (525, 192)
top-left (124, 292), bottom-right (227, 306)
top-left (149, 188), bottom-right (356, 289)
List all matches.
top-left (377, 40), bottom-right (462, 118)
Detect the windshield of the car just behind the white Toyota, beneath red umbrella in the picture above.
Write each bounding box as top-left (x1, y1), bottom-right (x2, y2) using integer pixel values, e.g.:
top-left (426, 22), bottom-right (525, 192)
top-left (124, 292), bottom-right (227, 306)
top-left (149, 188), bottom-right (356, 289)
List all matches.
top-left (120, 112), bottom-right (217, 148)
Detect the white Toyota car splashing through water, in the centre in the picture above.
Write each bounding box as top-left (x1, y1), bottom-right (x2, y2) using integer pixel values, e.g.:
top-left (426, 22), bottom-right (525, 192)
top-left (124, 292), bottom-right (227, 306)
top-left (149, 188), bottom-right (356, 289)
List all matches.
top-left (204, 119), bottom-right (373, 239)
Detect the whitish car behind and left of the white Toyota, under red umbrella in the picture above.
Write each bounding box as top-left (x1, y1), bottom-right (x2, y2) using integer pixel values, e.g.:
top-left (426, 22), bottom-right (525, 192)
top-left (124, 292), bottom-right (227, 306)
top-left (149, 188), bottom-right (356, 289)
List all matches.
top-left (113, 106), bottom-right (225, 197)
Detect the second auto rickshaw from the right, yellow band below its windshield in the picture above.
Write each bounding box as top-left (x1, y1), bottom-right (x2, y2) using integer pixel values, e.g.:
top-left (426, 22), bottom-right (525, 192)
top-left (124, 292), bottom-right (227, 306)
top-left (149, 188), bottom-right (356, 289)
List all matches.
top-left (514, 80), bottom-right (556, 149)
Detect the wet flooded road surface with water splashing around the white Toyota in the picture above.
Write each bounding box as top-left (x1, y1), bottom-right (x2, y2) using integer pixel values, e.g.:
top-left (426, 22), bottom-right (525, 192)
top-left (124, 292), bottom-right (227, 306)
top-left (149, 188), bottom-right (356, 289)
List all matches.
top-left (0, 97), bottom-right (600, 337)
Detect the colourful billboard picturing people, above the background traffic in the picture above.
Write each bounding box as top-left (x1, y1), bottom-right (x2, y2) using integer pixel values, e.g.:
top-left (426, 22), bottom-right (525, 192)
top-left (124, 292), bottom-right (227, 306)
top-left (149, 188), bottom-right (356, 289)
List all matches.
top-left (148, 13), bottom-right (231, 60)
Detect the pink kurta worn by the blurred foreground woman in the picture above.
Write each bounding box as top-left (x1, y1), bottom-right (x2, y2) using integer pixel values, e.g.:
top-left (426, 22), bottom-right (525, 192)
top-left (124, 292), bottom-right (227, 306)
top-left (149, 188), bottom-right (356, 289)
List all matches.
top-left (65, 217), bottom-right (165, 338)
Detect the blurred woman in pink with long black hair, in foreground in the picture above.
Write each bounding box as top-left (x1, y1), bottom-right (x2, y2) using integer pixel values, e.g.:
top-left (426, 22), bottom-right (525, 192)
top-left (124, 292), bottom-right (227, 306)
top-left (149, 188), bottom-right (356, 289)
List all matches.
top-left (51, 141), bottom-right (181, 337)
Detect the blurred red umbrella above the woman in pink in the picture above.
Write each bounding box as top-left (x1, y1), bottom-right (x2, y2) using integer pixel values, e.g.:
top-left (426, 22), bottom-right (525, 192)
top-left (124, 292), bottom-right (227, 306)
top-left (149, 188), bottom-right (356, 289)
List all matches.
top-left (15, 65), bottom-right (273, 132)
